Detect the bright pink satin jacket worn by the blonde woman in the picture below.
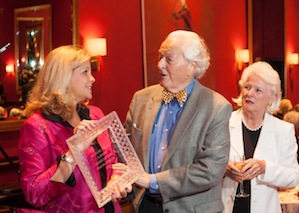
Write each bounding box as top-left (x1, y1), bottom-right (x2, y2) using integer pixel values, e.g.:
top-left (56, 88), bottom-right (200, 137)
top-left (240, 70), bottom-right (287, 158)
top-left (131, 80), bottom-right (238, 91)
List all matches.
top-left (19, 106), bottom-right (121, 213)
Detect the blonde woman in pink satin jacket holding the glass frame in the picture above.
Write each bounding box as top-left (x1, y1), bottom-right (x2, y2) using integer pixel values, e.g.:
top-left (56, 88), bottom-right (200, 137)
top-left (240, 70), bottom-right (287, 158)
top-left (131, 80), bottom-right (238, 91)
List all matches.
top-left (19, 46), bottom-right (131, 213)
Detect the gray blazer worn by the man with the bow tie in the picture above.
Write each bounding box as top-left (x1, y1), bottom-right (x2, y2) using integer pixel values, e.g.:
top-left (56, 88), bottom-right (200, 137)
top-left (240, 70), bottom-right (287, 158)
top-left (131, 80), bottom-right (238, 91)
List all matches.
top-left (124, 81), bottom-right (232, 213)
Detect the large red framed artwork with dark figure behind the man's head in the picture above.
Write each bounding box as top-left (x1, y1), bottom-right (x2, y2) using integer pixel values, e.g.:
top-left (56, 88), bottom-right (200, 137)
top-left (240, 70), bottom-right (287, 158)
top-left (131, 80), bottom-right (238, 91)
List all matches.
top-left (141, 0), bottom-right (207, 87)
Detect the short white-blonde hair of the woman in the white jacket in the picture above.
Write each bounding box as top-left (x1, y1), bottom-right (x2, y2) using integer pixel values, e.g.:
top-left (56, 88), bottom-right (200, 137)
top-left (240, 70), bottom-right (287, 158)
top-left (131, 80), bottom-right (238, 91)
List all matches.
top-left (232, 61), bottom-right (281, 114)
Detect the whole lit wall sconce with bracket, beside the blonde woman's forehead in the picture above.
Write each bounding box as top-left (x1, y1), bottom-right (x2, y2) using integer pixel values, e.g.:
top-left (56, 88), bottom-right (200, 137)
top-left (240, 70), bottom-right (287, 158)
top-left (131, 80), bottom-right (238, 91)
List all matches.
top-left (86, 38), bottom-right (107, 70)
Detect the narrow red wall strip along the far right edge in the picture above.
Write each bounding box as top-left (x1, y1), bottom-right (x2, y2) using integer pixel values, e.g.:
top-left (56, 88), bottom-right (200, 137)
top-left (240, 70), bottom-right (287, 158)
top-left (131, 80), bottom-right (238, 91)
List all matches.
top-left (285, 0), bottom-right (299, 105)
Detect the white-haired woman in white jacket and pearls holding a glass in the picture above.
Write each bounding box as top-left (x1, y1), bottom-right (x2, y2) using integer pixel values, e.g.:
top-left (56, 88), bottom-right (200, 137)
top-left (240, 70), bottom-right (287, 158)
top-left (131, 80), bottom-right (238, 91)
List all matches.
top-left (222, 62), bottom-right (299, 213)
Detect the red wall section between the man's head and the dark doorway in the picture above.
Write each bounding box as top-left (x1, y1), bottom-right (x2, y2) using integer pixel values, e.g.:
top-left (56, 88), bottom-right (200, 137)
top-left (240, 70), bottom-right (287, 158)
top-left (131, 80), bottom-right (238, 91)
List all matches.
top-left (209, 0), bottom-right (248, 101)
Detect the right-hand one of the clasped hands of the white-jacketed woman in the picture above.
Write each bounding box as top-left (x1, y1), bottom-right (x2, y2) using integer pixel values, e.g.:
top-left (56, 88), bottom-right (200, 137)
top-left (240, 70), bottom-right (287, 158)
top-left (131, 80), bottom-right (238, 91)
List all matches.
top-left (241, 158), bottom-right (266, 180)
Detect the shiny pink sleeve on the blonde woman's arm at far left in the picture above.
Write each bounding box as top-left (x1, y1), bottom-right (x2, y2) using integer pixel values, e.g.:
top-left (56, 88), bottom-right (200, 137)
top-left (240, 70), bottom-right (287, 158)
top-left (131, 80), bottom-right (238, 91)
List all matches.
top-left (19, 118), bottom-right (71, 206)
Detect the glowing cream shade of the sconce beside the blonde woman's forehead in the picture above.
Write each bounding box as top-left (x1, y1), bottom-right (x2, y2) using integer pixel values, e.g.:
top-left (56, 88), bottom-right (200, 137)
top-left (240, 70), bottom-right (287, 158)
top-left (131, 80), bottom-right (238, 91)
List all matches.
top-left (85, 38), bottom-right (107, 56)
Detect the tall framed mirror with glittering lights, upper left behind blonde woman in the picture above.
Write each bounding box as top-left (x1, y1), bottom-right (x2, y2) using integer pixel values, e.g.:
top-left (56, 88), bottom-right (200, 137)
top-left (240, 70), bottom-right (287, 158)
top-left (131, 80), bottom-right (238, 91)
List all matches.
top-left (14, 4), bottom-right (52, 93)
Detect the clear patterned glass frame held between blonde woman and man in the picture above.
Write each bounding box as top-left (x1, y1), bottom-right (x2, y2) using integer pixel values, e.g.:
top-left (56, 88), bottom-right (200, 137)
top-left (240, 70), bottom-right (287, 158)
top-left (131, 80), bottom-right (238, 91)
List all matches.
top-left (66, 111), bottom-right (145, 208)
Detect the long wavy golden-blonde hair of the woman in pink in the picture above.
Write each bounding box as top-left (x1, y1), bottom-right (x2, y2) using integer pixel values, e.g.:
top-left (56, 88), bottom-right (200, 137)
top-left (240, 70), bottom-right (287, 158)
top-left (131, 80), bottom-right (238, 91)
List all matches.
top-left (25, 46), bottom-right (90, 120)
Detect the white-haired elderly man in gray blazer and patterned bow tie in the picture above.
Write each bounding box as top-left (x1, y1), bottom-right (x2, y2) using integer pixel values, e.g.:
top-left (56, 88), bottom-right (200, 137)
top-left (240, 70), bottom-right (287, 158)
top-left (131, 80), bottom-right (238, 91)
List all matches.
top-left (124, 30), bottom-right (231, 213)
